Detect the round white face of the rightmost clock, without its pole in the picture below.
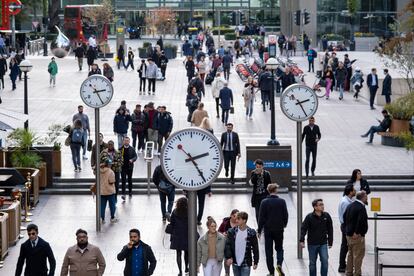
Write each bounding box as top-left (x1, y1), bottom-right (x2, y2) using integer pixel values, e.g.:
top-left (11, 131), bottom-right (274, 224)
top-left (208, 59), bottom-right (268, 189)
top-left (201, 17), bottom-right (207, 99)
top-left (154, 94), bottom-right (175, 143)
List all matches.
top-left (280, 84), bottom-right (318, 121)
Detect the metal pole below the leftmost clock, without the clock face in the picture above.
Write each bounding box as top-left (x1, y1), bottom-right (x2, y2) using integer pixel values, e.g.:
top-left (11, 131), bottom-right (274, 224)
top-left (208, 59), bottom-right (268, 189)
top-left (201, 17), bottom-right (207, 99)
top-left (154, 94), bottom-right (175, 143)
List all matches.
top-left (95, 108), bottom-right (101, 232)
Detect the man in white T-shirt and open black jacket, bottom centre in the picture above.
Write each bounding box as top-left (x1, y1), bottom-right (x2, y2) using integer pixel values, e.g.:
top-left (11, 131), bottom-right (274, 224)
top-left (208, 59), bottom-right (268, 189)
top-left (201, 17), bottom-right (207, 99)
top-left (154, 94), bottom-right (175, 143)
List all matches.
top-left (224, 212), bottom-right (259, 276)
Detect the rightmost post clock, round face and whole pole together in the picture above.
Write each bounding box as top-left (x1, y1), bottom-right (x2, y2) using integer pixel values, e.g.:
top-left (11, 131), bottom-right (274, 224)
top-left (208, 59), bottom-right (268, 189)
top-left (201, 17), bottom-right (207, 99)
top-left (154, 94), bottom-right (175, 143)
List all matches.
top-left (280, 84), bottom-right (318, 259)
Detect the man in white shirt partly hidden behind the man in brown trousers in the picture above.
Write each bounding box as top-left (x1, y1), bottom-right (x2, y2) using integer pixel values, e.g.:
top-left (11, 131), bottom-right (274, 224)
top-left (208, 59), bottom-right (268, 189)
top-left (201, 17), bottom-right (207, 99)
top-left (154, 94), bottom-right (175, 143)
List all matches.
top-left (338, 184), bottom-right (356, 273)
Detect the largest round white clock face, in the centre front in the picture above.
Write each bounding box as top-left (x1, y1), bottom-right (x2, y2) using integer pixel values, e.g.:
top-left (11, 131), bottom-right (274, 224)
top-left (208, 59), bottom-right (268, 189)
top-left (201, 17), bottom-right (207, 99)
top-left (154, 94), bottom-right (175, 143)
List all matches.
top-left (161, 128), bottom-right (223, 191)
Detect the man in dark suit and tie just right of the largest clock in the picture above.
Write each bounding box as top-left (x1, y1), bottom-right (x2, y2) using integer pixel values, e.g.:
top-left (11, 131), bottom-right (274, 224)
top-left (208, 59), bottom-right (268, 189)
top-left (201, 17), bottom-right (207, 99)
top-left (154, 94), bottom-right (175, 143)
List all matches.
top-left (220, 123), bottom-right (241, 184)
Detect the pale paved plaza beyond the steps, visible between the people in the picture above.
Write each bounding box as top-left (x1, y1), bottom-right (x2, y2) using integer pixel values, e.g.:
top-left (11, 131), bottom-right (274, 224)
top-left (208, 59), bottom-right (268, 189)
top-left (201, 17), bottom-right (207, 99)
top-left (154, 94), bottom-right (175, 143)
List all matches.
top-left (0, 40), bottom-right (414, 178)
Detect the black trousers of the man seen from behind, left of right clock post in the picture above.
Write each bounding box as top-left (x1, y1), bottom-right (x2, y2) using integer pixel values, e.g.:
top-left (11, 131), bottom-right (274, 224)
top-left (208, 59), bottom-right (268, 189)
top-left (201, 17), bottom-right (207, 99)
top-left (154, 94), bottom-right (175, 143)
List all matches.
top-left (264, 230), bottom-right (283, 275)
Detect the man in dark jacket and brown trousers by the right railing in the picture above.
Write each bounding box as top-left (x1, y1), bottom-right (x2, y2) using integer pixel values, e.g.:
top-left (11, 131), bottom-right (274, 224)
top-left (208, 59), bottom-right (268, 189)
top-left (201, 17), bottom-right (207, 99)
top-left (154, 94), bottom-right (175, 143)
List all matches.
top-left (344, 191), bottom-right (368, 276)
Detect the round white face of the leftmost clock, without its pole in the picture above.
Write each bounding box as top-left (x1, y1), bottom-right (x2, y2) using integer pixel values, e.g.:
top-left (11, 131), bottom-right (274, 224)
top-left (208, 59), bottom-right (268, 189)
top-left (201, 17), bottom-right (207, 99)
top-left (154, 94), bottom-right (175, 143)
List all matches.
top-left (80, 75), bottom-right (114, 108)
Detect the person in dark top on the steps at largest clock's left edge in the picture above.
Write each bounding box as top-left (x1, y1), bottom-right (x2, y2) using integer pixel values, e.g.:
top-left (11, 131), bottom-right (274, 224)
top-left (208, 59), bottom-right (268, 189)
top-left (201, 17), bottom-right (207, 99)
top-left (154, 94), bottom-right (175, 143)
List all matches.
top-left (152, 165), bottom-right (175, 222)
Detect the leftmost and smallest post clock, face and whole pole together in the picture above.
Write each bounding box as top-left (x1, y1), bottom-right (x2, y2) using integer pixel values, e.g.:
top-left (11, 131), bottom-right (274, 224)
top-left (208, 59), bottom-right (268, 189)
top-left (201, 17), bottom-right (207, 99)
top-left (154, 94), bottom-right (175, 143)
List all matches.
top-left (80, 75), bottom-right (114, 232)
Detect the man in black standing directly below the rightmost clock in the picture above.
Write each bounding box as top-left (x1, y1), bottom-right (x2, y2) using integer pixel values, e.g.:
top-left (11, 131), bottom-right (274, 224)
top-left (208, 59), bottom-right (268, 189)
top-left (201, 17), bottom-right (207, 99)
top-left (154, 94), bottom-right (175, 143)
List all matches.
top-left (302, 117), bottom-right (321, 177)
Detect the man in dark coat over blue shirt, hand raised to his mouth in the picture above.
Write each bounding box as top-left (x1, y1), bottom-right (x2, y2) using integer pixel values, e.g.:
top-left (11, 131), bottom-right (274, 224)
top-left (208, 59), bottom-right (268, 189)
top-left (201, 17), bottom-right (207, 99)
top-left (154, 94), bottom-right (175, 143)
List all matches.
top-left (117, 229), bottom-right (157, 276)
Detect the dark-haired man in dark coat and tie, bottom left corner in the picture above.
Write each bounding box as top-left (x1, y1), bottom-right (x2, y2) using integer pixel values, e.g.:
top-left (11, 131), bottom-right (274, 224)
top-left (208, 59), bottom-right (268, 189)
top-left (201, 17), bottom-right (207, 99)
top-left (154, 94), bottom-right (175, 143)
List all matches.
top-left (15, 224), bottom-right (56, 276)
